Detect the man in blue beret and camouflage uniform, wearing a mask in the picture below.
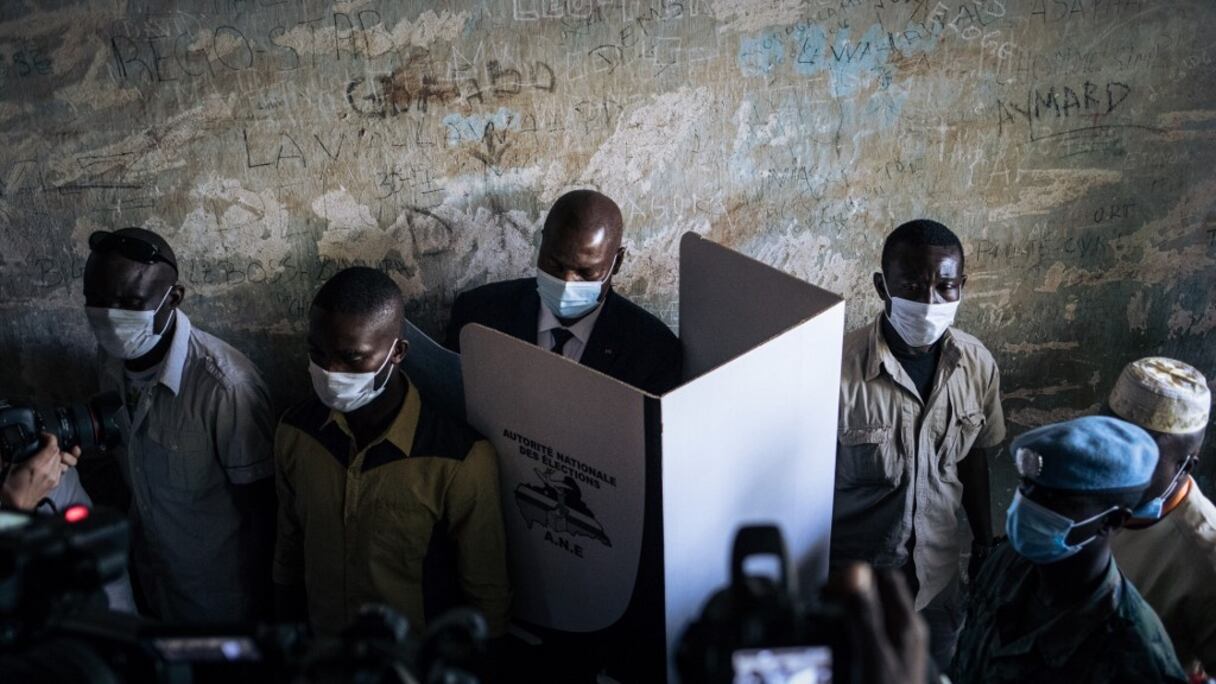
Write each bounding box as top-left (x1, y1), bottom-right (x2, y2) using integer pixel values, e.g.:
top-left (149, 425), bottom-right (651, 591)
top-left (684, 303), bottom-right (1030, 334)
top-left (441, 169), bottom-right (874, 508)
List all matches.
top-left (951, 416), bottom-right (1186, 684)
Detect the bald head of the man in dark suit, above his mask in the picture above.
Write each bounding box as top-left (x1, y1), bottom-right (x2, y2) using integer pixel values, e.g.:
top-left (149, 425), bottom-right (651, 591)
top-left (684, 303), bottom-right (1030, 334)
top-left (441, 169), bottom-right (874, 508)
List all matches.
top-left (536, 190), bottom-right (625, 291)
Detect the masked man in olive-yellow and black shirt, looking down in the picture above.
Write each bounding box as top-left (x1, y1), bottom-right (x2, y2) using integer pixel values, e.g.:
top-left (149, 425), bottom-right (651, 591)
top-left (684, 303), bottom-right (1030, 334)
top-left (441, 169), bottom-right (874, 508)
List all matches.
top-left (274, 268), bottom-right (511, 635)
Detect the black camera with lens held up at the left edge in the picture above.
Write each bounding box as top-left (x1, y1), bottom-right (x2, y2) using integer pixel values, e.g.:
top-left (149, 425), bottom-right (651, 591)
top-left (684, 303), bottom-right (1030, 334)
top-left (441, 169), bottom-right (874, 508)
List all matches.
top-left (0, 392), bottom-right (123, 465)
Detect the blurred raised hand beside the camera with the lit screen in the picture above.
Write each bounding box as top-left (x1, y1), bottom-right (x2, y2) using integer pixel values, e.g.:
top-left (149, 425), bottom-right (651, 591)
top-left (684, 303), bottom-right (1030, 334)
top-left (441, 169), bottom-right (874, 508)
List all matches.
top-left (834, 564), bottom-right (929, 684)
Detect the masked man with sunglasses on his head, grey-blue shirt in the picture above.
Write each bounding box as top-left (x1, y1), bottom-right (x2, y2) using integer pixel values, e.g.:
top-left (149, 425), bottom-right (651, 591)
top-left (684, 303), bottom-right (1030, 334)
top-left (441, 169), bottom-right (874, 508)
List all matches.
top-left (84, 228), bottom-right (275, 623)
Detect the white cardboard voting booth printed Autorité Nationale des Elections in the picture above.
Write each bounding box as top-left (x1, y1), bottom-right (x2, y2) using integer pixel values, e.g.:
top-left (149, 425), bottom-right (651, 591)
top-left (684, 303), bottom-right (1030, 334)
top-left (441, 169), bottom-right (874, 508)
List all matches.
top-left (461, 234), bottom-right (844, 680)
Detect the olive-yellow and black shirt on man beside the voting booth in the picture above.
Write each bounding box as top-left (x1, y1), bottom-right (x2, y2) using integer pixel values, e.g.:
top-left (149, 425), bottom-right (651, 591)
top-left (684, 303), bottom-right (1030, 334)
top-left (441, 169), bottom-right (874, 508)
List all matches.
top-left (274, 377), bottom-right (511, 637)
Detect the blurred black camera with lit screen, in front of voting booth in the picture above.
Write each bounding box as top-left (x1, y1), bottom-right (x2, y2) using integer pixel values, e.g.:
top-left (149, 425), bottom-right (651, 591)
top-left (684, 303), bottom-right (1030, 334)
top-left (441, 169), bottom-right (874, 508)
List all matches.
top-left (676, 525), bottom-right (851, 684)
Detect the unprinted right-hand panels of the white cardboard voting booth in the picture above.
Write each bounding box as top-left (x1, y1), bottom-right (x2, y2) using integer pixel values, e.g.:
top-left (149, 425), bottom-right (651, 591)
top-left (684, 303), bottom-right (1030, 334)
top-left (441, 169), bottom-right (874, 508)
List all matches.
top-left (662, 235), bottom-right (844, 666)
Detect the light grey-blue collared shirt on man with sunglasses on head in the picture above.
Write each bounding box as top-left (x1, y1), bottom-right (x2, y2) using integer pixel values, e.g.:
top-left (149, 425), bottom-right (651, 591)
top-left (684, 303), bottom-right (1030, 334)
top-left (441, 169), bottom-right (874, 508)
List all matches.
top-left (100, 310), bottom-right (274, 622)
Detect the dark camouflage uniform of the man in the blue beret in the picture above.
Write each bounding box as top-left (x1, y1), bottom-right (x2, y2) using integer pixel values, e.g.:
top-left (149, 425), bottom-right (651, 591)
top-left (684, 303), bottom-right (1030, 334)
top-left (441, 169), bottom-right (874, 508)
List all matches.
top-left (951, 544), bottom-right (1187, 684)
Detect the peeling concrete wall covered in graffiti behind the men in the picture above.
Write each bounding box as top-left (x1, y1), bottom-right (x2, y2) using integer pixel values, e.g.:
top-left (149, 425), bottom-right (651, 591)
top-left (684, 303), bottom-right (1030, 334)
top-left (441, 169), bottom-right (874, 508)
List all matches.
top-left (0, 0), bottom-right (1216, 500)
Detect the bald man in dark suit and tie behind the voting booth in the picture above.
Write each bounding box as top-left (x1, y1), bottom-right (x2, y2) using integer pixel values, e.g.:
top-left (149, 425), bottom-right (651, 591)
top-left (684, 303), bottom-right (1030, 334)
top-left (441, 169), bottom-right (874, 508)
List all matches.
top-left (444, 190), bottom-right (683, 394)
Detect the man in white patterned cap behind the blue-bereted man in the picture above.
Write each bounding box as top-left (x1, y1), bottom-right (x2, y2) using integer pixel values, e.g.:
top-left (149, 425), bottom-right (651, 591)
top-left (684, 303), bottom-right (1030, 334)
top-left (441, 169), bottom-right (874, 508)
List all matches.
top-left (1109, 357), bottom-right (1216, 673)
